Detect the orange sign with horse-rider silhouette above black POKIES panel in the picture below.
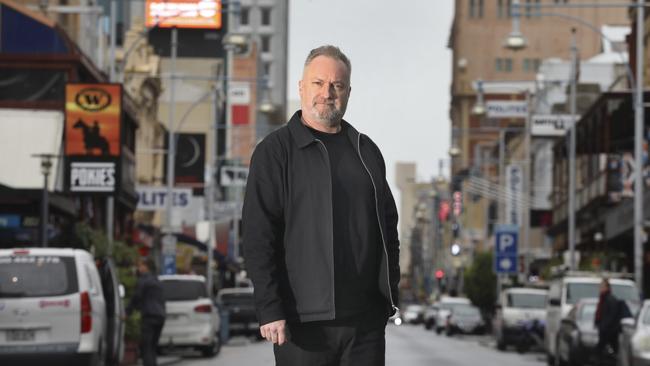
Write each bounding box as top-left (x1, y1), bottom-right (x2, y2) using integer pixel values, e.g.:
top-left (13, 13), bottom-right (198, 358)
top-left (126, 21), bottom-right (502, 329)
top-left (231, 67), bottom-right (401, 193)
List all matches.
top-left (65, 84), bottom-right (122, 194)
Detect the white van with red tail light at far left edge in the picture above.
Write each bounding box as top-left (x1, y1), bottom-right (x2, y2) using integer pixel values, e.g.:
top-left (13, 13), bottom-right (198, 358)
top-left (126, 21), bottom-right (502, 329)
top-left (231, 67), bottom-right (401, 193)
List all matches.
top-left (0, 248), bottom-right (108, 365)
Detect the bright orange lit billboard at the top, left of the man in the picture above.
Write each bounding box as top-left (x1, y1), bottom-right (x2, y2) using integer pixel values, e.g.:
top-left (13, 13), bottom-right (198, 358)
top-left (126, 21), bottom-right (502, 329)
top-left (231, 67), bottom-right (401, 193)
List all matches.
top-left (145, 0), bottom-right (222, 29)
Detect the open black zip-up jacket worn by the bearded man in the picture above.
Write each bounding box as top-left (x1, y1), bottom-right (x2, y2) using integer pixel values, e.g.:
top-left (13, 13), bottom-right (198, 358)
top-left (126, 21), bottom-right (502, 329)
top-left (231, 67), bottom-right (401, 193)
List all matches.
top-left (242, 111), bottom-right (400, 324)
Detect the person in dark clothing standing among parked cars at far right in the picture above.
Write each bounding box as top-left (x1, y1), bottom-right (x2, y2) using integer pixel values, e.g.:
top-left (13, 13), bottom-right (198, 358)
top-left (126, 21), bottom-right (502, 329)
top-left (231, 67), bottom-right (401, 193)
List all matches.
top-left (594, 278), bottom-right (625, 362)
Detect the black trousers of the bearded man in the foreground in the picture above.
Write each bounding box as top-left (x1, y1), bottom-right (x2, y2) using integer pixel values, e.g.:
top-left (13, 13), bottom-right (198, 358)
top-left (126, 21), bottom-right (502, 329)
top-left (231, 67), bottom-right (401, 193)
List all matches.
top-left (273, 314), bottom-right (386, 366)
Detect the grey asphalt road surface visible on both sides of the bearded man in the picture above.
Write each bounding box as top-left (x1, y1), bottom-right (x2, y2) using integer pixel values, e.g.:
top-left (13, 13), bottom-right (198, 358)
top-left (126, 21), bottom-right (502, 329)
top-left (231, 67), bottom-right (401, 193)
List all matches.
top-left (165, 325), bottom-right (545, 366)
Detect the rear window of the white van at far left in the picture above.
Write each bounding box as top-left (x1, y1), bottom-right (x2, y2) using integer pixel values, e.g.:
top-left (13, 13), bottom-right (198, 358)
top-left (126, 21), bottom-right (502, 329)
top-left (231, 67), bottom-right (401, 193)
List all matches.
top-left (0, 255), bottom-right (79, 298)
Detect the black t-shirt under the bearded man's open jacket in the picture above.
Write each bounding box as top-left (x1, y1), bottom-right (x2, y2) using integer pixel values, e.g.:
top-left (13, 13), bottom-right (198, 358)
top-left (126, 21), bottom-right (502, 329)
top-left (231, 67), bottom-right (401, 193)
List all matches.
top-left (310, 122), bottom-right (382, 319)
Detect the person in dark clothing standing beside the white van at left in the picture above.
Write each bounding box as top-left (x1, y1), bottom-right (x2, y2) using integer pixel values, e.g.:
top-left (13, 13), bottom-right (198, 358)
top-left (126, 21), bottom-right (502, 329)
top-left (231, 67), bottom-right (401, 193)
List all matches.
top-left (126, 258), bottom-right (165, 366)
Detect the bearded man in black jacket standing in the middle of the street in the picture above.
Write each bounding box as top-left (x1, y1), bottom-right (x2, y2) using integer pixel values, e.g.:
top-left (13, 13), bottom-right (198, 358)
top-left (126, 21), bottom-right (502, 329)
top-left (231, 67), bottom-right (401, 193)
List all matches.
top-left (243, 46), bottom-right (399, 366)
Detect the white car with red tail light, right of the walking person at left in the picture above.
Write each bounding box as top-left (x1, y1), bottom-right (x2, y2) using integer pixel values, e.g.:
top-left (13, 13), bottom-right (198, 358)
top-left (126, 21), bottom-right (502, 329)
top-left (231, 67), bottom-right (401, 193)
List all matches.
top-left (158, 275), bottom-right (221, 357)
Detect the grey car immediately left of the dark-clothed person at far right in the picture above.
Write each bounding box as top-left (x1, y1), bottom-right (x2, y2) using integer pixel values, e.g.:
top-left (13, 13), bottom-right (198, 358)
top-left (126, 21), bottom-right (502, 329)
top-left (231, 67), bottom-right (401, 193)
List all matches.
top-left (556, 298), bottom-right (598, 365)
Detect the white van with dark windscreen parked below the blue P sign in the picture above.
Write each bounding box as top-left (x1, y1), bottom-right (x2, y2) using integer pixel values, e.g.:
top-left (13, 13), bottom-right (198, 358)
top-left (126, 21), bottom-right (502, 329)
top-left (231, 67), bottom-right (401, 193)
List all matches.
top-left (494, 287), bottom-right (548, 350)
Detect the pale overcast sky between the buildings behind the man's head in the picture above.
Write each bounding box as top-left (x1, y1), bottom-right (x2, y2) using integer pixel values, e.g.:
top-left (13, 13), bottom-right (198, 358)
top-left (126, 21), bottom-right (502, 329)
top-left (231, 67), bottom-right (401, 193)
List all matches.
top-left (289, 0), bottom-right (454, 190)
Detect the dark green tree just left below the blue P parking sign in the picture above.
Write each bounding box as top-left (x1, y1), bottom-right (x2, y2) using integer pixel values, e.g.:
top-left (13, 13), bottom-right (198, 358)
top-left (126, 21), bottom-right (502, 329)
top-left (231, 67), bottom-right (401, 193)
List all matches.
top-left (464, 251), bottom-right (497, 314)
